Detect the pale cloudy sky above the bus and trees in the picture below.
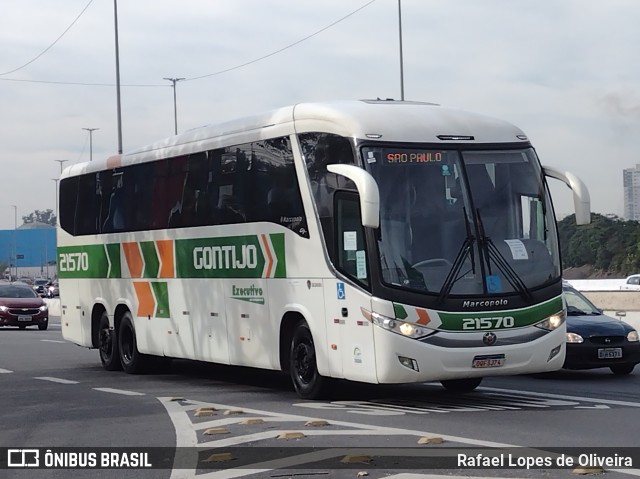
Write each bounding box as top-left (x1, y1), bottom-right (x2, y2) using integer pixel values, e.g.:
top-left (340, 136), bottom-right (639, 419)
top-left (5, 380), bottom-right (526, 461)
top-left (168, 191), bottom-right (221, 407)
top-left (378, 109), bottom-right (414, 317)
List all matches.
top-left (0, 0), bottom-right (640, 229)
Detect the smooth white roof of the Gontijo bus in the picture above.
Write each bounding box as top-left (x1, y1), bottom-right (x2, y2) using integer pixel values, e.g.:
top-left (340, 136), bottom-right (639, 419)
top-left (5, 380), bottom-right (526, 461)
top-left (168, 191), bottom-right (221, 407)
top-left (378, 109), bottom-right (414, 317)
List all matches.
top-left (63, 100), bottom-right (528, 177)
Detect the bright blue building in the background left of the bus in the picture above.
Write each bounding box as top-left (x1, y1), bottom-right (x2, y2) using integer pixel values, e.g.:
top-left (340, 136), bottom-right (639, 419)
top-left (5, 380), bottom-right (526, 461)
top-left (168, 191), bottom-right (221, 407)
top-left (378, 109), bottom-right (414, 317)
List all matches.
top-left (0, 223), bottom-right (57, 278)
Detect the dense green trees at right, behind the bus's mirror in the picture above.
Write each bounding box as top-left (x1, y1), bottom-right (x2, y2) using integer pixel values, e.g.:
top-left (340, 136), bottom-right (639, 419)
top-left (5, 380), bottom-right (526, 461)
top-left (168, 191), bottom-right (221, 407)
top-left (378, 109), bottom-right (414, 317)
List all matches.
top-left (558, 213), bottom-right (640, 276)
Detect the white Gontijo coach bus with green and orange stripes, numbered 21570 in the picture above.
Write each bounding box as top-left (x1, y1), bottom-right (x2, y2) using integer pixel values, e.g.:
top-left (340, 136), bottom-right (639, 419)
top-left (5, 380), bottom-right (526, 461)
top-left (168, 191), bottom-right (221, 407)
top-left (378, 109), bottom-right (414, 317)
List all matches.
top-left (58, 100), bottom-right (590, 398)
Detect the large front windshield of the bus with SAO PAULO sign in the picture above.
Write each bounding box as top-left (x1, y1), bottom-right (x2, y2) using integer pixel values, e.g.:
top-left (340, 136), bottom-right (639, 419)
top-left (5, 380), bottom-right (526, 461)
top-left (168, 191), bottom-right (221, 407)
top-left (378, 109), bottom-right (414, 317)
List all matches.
top-left (362, 146), bottom-right (560, 297)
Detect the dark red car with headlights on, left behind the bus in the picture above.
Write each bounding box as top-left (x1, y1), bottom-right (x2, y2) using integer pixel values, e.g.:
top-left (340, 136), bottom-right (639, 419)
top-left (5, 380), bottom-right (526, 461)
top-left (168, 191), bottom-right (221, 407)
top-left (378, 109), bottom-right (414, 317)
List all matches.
top-left (0, 283), bottom-right (49, 330)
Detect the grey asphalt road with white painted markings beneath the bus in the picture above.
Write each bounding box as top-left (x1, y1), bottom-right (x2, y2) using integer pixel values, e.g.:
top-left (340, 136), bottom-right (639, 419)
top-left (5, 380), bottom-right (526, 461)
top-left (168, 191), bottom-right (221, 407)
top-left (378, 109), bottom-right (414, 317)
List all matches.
top-left (0, 317), bottom-right (640, 479)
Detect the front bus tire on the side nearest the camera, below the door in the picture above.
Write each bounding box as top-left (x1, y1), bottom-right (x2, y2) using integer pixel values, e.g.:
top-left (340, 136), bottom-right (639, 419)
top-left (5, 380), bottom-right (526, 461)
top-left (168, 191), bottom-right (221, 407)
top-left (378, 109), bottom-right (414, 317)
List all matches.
top-left (289, 321), bottom-right (326, 399)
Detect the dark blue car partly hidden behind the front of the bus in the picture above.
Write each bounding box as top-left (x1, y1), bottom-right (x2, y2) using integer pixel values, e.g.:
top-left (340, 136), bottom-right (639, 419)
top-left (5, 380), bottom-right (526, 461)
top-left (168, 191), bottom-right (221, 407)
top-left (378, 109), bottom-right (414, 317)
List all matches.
top-left (563, 284), bottom-right (640, 374)
